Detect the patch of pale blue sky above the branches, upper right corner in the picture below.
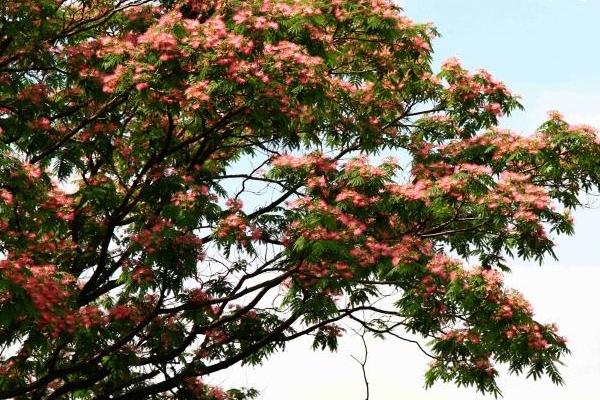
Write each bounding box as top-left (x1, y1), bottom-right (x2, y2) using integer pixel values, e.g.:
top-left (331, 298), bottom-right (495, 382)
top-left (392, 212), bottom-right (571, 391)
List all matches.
top-left (400, 0), bottom-right (600, 135)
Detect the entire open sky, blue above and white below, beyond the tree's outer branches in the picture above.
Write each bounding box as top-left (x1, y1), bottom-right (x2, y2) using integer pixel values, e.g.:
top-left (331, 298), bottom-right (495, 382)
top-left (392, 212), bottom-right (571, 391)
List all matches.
top-left (211, 0), bottom-right (600, 400)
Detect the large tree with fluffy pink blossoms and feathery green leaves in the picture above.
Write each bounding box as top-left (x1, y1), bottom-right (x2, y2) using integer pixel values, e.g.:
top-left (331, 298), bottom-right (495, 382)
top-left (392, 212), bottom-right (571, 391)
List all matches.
top-left (0, 0), bottom-right (600, 399)
